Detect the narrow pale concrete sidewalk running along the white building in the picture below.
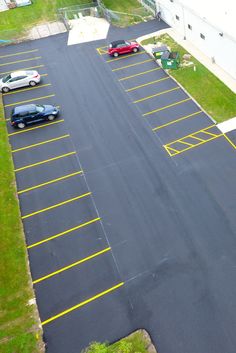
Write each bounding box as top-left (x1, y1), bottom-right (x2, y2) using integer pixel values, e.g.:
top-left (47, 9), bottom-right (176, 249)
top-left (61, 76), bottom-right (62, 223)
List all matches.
top-left (139, 28), bottom-right (236, 93)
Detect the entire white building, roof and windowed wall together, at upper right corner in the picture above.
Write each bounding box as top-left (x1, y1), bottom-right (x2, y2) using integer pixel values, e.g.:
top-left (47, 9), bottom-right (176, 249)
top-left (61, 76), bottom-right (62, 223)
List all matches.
top-left (156, 0), bottom-right (236, 79)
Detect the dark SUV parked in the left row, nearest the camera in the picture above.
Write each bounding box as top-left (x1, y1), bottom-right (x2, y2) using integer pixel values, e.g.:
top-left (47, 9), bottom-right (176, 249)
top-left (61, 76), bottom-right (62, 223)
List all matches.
top-left (11, 104), bottom-right (59, 129)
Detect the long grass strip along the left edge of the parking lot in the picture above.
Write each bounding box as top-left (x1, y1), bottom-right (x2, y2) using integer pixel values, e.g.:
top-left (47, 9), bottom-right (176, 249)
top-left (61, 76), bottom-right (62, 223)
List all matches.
top-left (0, 94), bottom-right (42, 353)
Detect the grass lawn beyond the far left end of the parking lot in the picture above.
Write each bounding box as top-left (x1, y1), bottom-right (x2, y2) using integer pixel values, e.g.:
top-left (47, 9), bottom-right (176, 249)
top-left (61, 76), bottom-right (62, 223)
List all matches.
top-left (0, 0), bottom-right (92, 39)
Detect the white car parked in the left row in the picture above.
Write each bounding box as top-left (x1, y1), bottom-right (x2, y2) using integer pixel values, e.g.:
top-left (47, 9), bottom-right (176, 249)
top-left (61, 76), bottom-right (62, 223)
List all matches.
top-left (0, 70), bottom-right (40, 93)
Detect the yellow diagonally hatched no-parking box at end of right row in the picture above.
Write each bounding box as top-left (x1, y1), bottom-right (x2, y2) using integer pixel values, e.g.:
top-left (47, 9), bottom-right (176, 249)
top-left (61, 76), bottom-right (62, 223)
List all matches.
top-left (163, 125), bottom-right (224, 157)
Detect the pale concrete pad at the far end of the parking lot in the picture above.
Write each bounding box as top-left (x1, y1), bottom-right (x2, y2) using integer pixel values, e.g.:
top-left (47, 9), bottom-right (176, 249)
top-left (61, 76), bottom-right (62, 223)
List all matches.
top-left (67, 16), bottom-right (110, 45)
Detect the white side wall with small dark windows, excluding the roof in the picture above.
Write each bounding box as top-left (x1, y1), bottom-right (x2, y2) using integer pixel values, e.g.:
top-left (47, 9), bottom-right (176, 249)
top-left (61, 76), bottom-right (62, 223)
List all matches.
top-left (156, 0), bottom-right (236, 79)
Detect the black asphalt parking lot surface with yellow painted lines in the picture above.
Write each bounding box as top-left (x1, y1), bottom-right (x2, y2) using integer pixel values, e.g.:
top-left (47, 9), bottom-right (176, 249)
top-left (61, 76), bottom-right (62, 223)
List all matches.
top-left (0, 21), bottom-right (236, 353)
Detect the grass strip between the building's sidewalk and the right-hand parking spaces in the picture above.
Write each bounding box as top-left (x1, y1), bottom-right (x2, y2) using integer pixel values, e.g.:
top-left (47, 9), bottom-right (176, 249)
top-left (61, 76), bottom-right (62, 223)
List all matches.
top-left (142, 34), bottom-right (236, 122)
